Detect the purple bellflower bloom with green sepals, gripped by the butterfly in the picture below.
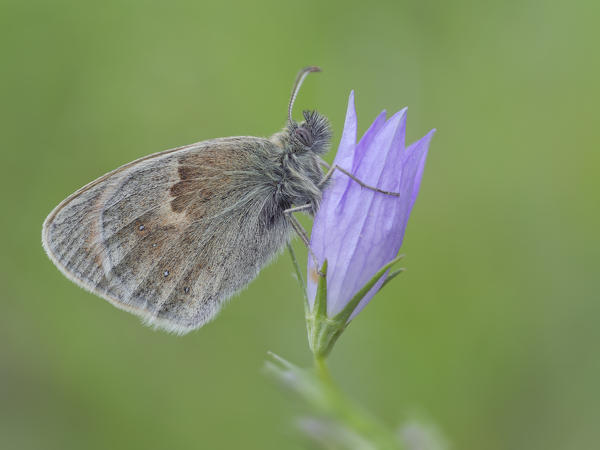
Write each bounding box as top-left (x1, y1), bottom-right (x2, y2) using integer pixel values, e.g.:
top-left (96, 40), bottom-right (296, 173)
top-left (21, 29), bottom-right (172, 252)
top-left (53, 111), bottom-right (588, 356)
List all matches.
top-left (307, 92), bottom-right (435, 357)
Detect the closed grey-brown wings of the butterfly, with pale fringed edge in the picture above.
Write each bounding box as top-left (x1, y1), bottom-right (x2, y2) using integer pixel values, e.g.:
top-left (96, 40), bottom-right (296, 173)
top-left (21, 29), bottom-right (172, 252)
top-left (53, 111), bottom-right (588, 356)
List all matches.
top-left (42, 137), bottom-right (290, 333)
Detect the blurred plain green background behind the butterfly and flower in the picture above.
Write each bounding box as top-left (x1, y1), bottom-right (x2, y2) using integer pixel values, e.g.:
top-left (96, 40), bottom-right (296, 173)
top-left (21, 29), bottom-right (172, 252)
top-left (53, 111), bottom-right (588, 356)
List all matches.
top-left (0, 0), bottom-right (600, 450)
